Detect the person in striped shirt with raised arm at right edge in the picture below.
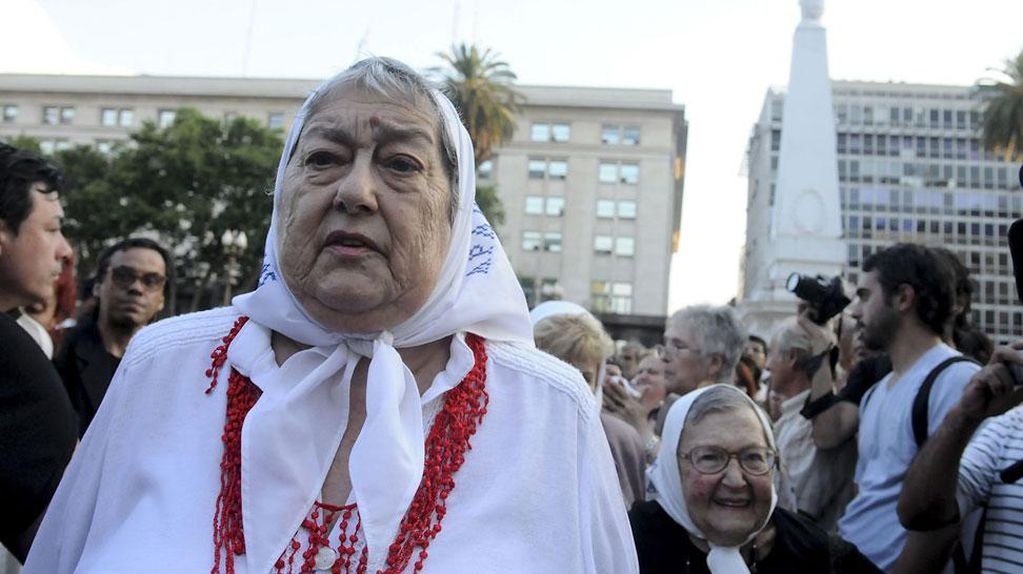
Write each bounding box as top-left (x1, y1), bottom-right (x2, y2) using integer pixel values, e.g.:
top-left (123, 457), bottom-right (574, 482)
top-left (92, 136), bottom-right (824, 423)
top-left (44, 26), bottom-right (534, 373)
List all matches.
top-left (898, 341), bottom-right (1023, 571)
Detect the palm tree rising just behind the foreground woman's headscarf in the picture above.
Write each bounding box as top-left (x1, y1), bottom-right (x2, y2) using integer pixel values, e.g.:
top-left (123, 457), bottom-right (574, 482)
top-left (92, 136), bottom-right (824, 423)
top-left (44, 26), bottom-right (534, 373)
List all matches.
top-left (433, 43), bottom-right (525, 167)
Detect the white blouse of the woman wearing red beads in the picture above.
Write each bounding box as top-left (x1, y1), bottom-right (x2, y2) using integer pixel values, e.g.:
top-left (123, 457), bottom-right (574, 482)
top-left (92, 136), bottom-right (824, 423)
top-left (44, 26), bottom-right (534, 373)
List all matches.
top-left (26, 308), bottom-right (637, 574)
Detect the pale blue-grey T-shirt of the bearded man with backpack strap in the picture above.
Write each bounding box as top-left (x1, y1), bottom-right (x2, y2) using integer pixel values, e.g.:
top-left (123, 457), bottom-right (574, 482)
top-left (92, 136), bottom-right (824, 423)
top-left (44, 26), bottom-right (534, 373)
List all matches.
top-left (839, 344), bottom-right (980, 571)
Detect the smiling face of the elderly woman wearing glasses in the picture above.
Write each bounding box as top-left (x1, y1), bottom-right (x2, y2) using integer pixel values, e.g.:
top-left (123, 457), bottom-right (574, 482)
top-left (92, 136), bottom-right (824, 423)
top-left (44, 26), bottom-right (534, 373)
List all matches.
top-left (677, 408), bottom-right (773, 546)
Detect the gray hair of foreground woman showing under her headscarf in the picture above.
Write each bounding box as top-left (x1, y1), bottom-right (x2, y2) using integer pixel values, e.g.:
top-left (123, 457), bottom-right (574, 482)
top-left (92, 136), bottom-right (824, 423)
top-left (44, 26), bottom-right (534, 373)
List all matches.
top-left (293, 56), bottom-right (458, 223)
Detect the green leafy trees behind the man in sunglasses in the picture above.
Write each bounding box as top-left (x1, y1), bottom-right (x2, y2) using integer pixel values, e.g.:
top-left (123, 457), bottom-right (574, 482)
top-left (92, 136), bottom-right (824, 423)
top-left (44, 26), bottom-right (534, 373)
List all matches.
top-left (19, 108), bottom-right (283, 309)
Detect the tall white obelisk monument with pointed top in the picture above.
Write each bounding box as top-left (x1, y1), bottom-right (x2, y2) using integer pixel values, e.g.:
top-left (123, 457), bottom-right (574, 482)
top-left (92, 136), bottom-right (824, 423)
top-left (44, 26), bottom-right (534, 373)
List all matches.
top-left (737, 0), bottom-right (846, 337)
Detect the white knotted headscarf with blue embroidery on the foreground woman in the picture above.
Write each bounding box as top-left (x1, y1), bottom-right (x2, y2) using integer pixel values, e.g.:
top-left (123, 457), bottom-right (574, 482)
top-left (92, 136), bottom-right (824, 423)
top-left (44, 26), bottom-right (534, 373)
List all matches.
top-left (228, 60), bottom-right (533, 572)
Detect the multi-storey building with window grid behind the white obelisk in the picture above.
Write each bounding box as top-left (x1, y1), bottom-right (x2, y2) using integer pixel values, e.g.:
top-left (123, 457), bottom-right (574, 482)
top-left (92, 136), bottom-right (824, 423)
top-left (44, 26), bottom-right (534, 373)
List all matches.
top-left (740, 82), bottom-right (1023, 342)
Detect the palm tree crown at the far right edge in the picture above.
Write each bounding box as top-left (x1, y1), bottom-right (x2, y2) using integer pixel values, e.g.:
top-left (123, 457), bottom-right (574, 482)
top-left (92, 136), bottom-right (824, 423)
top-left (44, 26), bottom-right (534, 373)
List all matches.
top-left (977, 51), bottom-right (1023, 161)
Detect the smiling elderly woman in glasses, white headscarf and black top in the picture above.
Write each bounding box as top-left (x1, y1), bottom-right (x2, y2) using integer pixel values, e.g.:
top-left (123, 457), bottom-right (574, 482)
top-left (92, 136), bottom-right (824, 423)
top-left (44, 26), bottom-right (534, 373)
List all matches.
top-left (629, 384), bottom-right (875, 574)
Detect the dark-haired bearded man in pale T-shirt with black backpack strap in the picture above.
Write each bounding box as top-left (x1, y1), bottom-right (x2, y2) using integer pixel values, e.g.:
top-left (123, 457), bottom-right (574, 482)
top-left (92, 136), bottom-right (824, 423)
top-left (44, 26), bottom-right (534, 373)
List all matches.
top-left (839, 244), bottom-right (978, 571)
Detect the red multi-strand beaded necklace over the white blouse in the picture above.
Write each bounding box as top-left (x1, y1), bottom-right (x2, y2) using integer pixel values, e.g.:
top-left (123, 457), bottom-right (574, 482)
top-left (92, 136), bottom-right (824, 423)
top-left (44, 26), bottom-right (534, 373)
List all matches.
top-left (206, 317), bottom-right (490, 574)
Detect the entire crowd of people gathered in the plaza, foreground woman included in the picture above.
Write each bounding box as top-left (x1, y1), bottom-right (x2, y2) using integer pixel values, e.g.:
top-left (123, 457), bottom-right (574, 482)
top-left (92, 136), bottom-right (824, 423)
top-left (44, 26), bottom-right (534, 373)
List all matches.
top-left (0, 57), bottom-right (1023, 574)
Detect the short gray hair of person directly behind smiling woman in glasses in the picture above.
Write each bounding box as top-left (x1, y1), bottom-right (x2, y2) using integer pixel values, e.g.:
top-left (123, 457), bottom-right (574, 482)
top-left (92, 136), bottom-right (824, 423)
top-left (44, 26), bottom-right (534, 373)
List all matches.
top-left (668, 305), bottom-right (746, 383)
